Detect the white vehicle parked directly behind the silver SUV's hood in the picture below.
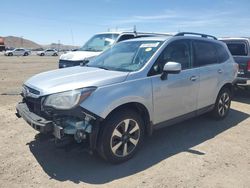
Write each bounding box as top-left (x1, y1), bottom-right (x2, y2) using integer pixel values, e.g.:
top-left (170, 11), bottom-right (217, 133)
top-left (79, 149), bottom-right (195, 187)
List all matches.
top-left (59, 32), bottom-right (170, 68)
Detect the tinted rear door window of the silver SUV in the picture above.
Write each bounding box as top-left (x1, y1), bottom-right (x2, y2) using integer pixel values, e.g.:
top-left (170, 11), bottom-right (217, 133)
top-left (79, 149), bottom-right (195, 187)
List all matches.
top-left (193, 41), bottom-right (218, 67)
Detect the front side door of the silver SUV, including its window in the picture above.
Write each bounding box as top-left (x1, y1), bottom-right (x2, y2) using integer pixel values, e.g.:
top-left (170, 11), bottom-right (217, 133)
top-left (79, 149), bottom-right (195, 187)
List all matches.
top-left (149, 40), bottom-right (199, 123)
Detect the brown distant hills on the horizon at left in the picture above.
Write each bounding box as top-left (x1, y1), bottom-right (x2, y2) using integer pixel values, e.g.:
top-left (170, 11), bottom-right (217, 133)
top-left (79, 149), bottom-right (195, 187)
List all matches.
top-left (4, 36), bottom-right (79, 50)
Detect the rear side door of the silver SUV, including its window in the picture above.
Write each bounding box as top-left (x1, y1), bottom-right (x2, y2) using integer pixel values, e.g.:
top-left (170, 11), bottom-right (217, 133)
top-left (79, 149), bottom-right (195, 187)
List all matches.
top-left (193, 40), bottom-right (225, 109)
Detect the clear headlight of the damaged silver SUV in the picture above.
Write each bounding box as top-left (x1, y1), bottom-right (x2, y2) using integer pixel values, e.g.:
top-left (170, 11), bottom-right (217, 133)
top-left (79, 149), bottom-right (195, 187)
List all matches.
top-left (44, 87), bottom-right (96, 110)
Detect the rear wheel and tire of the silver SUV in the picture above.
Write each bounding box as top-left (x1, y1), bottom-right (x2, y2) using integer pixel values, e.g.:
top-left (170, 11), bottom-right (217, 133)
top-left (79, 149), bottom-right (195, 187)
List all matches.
top-left (212, 88), bottom-right (232, 120)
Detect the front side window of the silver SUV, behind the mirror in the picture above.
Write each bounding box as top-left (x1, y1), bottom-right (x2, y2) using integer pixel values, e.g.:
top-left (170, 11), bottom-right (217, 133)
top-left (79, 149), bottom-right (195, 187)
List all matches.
top-left (149, 40), bottom-right (191, 76)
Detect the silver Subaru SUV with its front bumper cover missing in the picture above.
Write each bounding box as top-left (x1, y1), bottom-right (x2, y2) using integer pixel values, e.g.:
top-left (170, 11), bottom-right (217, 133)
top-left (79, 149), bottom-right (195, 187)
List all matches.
top-left (16, 33), bottom-right (237, 163)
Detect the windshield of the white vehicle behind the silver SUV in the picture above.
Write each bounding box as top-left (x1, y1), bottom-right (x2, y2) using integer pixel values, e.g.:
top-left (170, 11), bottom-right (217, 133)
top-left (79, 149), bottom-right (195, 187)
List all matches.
top-left (79, 34), bottom-right (119, 52)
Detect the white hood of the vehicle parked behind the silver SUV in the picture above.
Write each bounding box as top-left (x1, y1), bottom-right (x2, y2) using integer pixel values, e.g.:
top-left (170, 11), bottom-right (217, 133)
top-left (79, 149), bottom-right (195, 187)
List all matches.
top-left (60, 51), bottom-right (102, 61)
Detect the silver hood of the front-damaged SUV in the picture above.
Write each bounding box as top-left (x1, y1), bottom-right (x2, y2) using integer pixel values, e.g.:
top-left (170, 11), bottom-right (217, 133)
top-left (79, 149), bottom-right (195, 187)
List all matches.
top-left (24, 66), bottom-right (129, 96)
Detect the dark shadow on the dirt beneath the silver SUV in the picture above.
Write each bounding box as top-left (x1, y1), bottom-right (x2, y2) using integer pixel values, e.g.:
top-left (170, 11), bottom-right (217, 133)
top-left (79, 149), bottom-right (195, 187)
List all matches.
top-left (28, 109), bottom-right (249, 184)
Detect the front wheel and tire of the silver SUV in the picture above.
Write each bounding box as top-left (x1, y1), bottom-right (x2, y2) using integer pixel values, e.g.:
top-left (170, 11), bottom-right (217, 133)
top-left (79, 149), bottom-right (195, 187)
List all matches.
top-left (98, 110), bottom-right (144, 163)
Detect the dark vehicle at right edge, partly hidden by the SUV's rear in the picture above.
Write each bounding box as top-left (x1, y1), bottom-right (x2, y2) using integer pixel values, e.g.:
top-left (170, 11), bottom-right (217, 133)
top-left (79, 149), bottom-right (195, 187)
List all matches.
top-left (219, 37), bottom-right (250, 85)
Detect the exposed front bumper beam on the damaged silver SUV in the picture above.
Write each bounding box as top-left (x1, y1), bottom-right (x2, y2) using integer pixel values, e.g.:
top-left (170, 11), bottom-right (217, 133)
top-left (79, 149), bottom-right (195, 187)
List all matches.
top-left (16, 103), bottom-right (54, 133)
